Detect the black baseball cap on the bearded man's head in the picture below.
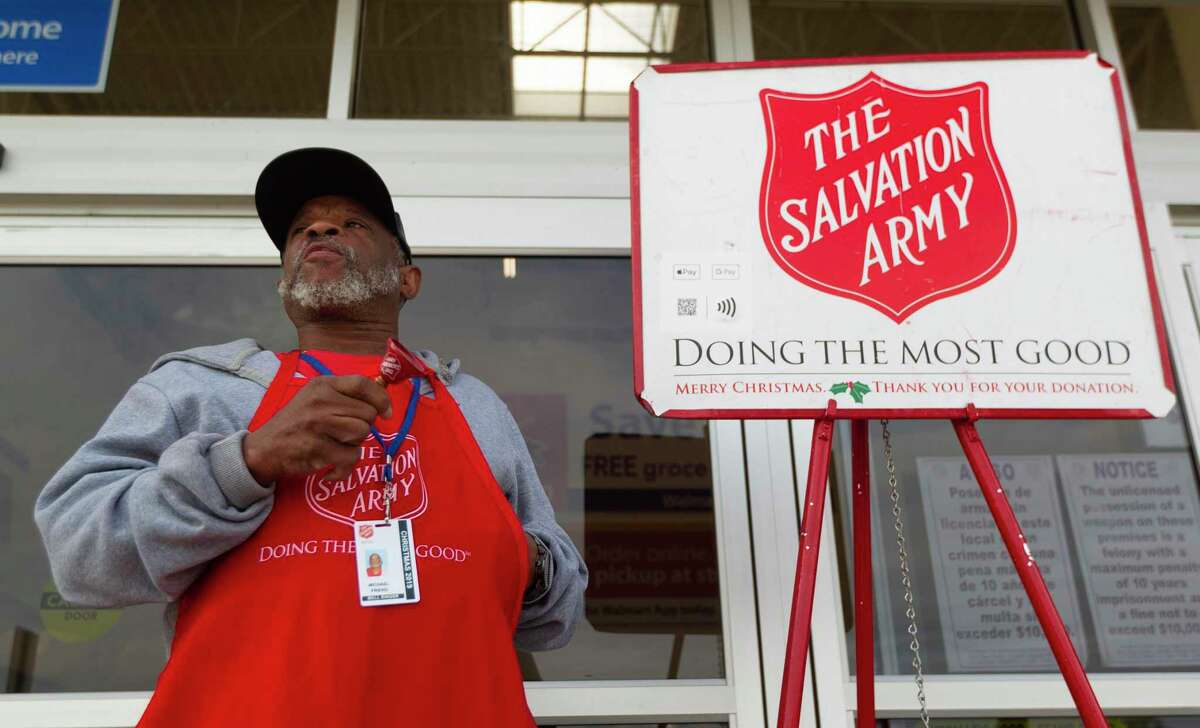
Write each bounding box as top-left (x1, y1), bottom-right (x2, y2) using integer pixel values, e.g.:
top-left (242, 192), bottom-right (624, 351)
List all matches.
top-left (254, 146), bottom-right (413, 263)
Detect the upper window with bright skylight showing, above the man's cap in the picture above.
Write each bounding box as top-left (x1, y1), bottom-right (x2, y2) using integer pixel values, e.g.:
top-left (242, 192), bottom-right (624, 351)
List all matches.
top-left (354, 0), bottom-right (710, 119)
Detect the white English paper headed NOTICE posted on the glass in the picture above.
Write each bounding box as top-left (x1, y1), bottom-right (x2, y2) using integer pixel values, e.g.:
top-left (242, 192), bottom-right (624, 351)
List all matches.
top-left (1058, 452), bottom-right (1200, 668)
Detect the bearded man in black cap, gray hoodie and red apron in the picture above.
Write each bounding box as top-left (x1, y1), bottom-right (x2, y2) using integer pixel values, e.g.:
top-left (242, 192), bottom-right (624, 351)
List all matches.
top-left (35, 149), bottom-right (587, 728)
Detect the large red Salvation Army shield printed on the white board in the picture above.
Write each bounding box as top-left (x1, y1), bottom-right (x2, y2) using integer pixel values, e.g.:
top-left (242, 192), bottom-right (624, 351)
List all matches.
top-left (760, 73), bottom-right (1016, 323)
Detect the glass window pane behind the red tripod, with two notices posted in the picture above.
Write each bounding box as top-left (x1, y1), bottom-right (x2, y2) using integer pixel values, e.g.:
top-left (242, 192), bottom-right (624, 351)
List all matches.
top-left (835, 408), bottom-right (1200, 674)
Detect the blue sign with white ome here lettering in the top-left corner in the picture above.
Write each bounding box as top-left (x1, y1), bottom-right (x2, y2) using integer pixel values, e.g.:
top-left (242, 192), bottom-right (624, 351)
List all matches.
top-left (0, 0), bottom-right (118, 92)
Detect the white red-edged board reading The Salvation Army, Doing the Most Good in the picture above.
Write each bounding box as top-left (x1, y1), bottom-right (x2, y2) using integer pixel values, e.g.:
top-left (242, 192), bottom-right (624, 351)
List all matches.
top-left (630, 53), bottom-right (1174, 417)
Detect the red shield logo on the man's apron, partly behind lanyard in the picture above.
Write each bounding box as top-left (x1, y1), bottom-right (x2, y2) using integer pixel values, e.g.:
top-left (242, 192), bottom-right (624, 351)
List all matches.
top-left (305, 433), bottom-right (430, 525)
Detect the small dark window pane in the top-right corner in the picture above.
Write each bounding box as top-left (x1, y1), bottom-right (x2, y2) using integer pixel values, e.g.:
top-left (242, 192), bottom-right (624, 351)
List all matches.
top-left (1110, 0), bottom-right (1200, 128)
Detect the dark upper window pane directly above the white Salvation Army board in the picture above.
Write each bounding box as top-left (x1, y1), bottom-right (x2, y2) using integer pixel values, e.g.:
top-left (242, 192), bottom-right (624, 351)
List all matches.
top-left (750, 0), bottom-right (1078, 60)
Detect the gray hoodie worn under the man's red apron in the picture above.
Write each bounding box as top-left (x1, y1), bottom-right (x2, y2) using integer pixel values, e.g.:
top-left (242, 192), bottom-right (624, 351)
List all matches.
top-left (34, 338), bottom-right (588, 650)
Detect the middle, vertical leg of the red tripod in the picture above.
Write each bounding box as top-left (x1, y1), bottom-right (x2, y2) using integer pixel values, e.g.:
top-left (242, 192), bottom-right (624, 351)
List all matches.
top-left (850, 420), bottom-right (875, 728)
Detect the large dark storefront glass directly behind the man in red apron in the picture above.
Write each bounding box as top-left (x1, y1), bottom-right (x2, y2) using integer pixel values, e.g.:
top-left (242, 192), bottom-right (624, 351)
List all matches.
top-left (0, 258), bottom-right (725, 692)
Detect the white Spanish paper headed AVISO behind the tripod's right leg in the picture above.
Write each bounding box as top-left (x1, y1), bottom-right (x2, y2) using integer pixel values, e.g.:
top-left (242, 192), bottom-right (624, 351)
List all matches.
top-left (917, 457), bottom-right (1087, 673)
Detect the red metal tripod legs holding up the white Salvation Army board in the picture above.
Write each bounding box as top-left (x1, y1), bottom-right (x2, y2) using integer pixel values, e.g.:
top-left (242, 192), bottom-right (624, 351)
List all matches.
top-left (776, 414), bottom-right (1108, 728)
